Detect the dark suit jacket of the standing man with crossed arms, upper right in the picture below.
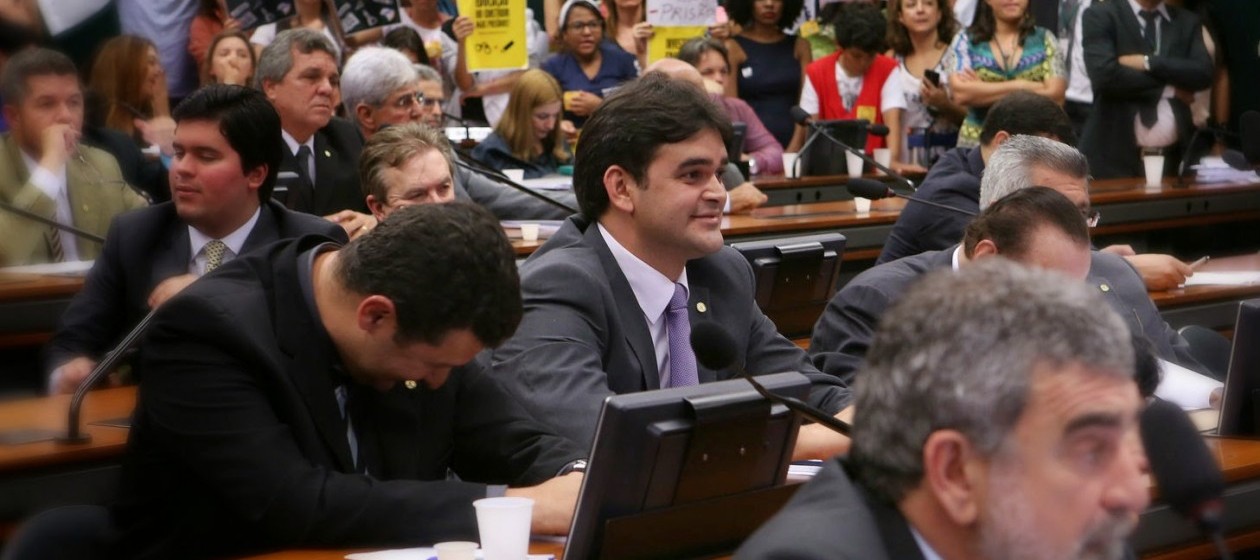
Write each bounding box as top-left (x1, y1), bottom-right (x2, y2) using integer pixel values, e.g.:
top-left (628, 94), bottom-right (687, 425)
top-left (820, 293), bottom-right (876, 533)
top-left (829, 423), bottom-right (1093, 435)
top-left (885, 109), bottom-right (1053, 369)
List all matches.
top-left (1081, 0), bottom-right (1212, 179)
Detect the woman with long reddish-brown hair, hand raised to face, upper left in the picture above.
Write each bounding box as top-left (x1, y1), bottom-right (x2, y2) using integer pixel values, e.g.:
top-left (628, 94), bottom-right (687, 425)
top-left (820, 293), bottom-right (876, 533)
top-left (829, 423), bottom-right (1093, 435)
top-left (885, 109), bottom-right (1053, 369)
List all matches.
top-left (89, 35), bottom-right (175, 155)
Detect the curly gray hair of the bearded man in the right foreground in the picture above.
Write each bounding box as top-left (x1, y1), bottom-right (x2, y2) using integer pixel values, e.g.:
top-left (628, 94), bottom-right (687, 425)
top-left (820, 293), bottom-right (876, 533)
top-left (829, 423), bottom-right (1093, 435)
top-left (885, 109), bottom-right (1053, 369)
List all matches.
top-left (851, 257), bottom-right (1134, 503)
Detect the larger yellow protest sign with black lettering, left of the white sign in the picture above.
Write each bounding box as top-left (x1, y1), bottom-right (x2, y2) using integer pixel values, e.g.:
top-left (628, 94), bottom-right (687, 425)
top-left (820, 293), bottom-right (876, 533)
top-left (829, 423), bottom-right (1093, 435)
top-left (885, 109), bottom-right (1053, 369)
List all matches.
top-left (459, 0), bottom-right (529, 72)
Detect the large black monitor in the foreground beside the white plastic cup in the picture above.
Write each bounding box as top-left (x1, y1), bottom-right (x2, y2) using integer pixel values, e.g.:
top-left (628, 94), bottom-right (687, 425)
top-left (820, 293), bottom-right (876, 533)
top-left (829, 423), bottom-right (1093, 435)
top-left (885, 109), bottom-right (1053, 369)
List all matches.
top-left (564, 373), bottom-right (809, 560)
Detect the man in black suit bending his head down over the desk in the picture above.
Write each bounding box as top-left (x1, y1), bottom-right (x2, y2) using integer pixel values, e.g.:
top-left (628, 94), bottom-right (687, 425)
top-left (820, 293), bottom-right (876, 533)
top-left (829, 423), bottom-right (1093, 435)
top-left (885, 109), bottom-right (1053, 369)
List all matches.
top-left (113, 202), bottom-right (582, 557)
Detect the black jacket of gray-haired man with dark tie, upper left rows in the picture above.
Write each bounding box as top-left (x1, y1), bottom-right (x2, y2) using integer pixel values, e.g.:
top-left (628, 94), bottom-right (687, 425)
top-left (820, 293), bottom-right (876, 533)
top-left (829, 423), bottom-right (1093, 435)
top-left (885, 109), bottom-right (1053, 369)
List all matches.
top-left (276, 117), bottom-right (368, 216)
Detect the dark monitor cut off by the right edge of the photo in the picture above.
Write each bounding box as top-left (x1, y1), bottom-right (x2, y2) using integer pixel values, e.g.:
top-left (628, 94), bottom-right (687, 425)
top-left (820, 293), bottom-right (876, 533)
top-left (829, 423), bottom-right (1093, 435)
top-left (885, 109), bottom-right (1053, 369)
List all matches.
top-left (1217, 299), bottom-right (1260, 435)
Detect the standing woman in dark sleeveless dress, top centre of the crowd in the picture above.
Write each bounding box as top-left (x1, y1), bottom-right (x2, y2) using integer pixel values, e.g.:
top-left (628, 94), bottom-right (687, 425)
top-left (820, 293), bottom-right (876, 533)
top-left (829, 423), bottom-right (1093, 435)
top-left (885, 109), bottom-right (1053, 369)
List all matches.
top-left (726, 0), bottom-right (813, 146)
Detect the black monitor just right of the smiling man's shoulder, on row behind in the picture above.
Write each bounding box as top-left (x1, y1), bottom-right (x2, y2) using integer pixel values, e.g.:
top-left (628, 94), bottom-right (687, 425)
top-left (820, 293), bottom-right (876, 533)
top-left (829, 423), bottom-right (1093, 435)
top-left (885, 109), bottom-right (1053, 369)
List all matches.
top-left (731, 233), bottom-right (845, 337)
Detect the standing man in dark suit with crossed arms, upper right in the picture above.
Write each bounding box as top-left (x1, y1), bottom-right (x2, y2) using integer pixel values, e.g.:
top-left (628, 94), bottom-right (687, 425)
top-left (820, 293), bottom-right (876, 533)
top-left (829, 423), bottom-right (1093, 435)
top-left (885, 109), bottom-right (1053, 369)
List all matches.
top-left (1081, 0), bottom-right (1213, 179)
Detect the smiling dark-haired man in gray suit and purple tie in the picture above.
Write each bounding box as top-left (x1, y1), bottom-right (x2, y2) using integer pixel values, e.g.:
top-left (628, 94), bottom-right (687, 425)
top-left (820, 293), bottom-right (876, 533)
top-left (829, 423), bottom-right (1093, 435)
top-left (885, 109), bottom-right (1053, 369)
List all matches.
top-left (493, 72), bottom-right (849, 457)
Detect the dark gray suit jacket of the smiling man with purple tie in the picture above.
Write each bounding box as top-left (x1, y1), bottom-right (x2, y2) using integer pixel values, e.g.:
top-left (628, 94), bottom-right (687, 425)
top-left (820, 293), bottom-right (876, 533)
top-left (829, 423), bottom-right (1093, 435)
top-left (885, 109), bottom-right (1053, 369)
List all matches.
top-left (493, 211), bottom-right (849, 444)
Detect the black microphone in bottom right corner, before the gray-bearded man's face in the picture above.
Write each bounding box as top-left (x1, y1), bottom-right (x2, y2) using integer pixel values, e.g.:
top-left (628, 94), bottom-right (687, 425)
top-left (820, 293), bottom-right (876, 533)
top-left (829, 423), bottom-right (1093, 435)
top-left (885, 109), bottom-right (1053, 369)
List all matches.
top-left (1142, 399), bottom-right (1231, 559)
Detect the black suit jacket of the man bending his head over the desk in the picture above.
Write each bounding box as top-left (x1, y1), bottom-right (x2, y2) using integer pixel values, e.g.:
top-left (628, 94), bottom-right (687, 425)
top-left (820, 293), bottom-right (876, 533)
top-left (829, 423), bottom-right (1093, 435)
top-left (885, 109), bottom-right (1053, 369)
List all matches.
top-left (113, 236), bottom-right (582, 557)
